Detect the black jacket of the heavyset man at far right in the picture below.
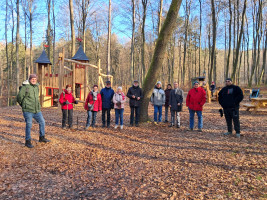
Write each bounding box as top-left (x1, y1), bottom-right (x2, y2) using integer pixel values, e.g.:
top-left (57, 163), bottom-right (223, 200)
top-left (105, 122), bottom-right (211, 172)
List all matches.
top-left (219, 85), bottom-right (244, 108)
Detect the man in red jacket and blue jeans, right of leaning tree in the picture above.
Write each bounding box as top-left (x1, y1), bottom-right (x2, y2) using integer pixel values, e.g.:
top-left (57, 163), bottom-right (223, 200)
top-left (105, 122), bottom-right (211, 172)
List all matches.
top-left (186, 81), bottom-right (206, 132)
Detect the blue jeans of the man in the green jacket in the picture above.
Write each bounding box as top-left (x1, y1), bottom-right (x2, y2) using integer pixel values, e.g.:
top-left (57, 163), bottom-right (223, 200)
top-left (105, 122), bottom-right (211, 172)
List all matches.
top-left (23, 112), bottom-right (45, 140)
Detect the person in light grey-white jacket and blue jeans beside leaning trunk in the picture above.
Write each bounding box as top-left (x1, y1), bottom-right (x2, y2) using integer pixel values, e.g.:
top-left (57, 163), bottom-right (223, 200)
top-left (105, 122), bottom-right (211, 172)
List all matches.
top-left (150, 81), bottom-right (166, 124)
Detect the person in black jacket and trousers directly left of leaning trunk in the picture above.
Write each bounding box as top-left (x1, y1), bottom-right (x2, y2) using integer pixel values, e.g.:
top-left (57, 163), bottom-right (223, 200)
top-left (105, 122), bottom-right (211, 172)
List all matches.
top-left (127, 81), bottom-right (143, 126)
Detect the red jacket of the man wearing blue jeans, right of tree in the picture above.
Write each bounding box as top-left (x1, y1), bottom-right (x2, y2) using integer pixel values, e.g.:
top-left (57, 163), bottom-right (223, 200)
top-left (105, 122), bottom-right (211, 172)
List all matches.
top-left (186, 87), bottom-right (206, 111)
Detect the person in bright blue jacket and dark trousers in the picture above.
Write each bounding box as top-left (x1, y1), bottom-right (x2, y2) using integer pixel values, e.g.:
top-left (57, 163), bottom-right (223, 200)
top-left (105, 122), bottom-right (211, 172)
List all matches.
top-left (100, 81), bottom-right (114, 128)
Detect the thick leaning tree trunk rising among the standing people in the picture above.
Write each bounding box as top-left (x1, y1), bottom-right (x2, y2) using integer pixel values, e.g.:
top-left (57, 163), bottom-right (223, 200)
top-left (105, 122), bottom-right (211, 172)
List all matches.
top-left (141, 0), bottom-right (182, 122)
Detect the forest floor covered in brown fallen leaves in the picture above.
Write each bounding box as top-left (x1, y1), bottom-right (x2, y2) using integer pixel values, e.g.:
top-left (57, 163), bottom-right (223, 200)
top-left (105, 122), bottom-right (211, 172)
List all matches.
top-left (0, 97), bottom-right (267, 200)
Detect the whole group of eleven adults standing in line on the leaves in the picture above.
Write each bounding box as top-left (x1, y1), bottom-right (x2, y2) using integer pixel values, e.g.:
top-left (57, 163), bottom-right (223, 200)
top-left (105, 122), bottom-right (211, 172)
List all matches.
top-left (17, 74), bottom-right (243, 148)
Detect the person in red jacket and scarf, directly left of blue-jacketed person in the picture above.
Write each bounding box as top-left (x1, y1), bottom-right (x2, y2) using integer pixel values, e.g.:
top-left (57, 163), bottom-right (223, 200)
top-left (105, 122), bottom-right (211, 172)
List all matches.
top-left (84, 85), bottom-right (102, 130)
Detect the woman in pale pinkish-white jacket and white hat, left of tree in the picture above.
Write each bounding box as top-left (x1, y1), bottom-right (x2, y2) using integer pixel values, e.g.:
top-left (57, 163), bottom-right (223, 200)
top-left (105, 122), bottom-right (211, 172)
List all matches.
top-left (113, 87), bottom-right (126, 129)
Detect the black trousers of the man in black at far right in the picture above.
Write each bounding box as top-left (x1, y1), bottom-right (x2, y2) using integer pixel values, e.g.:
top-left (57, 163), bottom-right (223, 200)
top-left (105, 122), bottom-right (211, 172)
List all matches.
top-left (223, 107), bottom-right (240, 133)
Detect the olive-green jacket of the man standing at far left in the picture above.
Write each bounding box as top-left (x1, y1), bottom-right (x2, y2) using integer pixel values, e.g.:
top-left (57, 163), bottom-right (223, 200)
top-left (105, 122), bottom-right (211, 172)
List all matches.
top-left (17, 80), bottom-right (41, 113)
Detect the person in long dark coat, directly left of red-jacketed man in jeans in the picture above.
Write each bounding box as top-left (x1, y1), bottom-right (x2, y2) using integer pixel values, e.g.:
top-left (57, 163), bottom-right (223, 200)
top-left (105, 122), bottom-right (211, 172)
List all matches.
top-left (169, 82), bottom-right (184, 128)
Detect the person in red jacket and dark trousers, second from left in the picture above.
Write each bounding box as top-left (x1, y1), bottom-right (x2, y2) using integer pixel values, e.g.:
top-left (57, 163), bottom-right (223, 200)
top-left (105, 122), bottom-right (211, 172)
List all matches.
top-left (59, 85), bottom-right (78, 129)
